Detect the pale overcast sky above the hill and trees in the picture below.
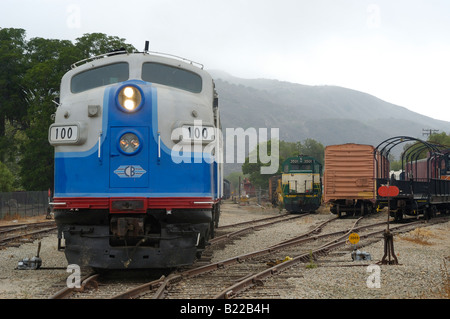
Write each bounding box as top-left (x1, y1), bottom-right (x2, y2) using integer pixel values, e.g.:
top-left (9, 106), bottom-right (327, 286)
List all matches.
top-left (0, 0), bottom-right (450, 123)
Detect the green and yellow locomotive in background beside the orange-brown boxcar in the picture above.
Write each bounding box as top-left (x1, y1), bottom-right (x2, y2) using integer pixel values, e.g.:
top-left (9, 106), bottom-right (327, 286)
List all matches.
top-left (281, 155), bottom-right (322, 213)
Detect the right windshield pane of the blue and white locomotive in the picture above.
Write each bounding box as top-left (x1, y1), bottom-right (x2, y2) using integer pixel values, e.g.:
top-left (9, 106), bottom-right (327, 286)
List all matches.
top-left (142, 62), bottom-right (202, 93)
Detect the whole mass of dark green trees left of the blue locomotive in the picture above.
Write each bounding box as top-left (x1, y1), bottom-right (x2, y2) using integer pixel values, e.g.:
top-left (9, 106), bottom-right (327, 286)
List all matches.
top-left (0, 28), bottom-right (136, 190)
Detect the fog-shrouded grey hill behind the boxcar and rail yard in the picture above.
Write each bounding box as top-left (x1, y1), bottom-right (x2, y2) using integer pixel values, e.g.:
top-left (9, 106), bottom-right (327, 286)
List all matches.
top-left (209, 70), bottom-right (450, 174)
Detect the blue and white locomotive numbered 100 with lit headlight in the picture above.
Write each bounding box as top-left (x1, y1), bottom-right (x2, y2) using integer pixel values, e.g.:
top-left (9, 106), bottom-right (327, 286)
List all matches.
top-left (49, 50), bottom-right (223, 269)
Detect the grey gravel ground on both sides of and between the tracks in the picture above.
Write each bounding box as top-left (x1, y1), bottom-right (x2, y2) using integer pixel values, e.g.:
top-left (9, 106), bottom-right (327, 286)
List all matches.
top-left (0, 203), bottom-right (450, 299)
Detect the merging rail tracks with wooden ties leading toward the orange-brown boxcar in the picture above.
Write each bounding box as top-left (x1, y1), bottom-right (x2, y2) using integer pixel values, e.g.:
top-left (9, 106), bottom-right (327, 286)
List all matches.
top-left (114, 218), bottom-right (428, 299)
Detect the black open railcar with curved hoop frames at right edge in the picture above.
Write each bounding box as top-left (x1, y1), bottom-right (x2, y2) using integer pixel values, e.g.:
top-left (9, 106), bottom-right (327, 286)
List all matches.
top-left (376, 136), bottom-right (450, 221)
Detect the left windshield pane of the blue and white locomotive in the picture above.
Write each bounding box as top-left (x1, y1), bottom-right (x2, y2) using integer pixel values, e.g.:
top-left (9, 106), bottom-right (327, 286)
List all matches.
top-left (70, 62), bottom-right (129, 93)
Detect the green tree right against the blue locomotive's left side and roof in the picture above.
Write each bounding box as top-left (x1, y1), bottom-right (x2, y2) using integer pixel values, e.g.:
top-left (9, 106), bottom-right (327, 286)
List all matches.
top-left (20, 33), bottom-right (133, 190)
